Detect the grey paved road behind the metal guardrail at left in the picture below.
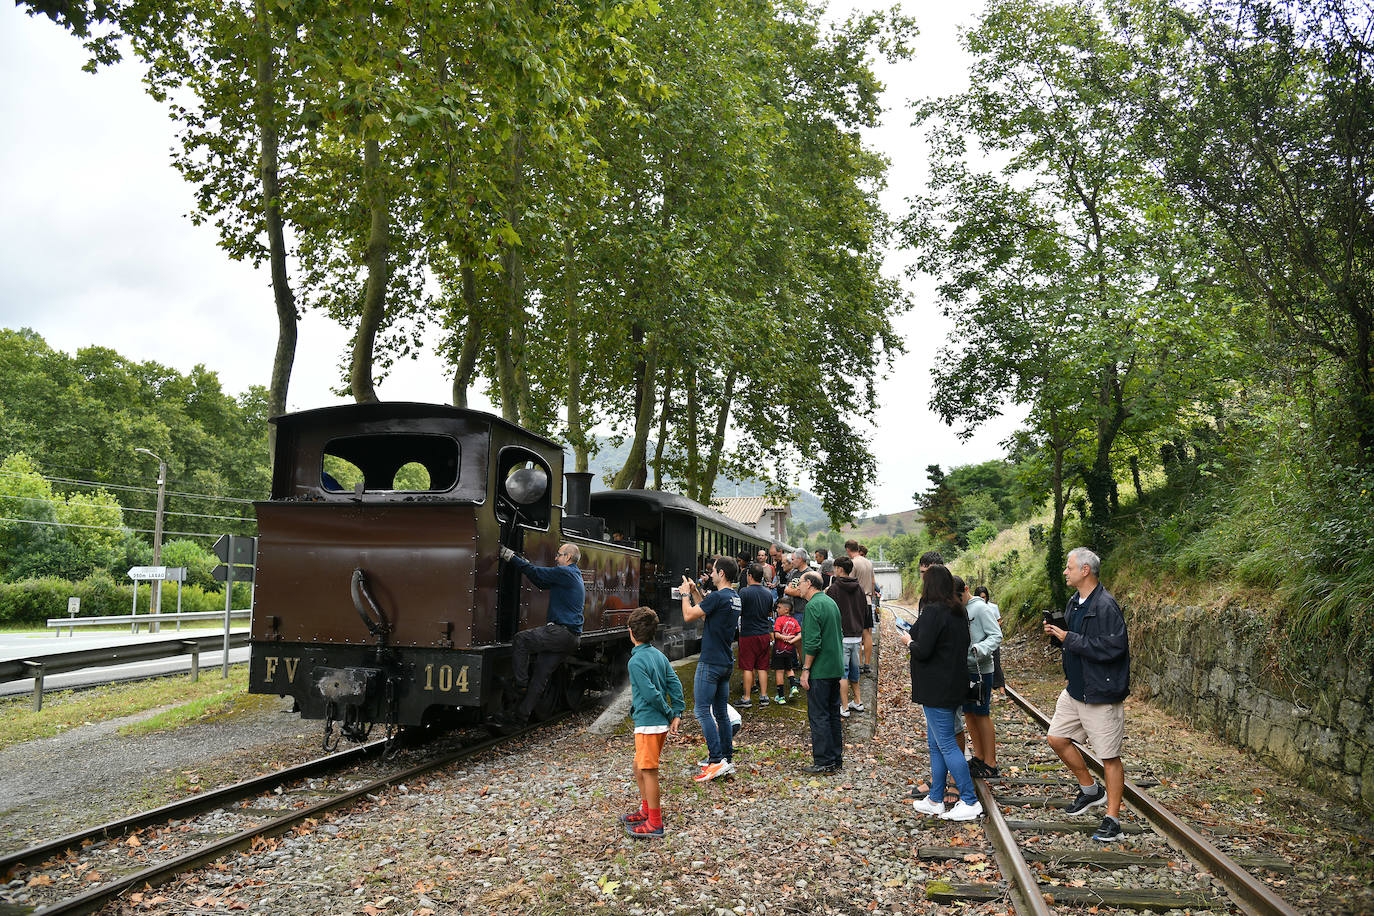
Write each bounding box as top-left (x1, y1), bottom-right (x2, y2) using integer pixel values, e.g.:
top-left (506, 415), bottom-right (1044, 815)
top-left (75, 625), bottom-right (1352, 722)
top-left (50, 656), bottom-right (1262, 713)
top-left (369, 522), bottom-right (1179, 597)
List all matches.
top-left (0, 625), bottom-right (249, 696)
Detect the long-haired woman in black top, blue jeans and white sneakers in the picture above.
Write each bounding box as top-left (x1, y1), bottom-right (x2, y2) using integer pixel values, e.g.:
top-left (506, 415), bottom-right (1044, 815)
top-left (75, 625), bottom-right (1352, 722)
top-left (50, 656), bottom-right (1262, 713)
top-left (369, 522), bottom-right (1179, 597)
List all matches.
top-left (899, 566), bottom-right (982, 820)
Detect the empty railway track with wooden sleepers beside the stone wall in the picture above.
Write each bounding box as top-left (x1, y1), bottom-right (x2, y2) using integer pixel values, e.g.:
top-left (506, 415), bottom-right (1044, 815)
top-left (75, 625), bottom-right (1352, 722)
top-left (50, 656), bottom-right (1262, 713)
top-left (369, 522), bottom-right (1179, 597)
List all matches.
top-left (918, 687), bottom-right (1297, 916)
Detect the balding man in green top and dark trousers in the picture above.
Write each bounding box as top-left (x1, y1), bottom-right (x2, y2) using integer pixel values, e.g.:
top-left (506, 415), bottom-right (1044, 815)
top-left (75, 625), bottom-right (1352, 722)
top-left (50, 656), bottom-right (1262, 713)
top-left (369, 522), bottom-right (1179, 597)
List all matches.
top-left (797, 570), bottom-right (845, 773)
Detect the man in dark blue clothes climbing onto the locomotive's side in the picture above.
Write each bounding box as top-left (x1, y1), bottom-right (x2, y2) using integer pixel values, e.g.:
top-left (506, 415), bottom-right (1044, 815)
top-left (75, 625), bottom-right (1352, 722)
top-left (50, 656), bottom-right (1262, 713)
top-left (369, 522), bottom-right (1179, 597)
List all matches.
top-left (495, 544), bottom-right (587, 728)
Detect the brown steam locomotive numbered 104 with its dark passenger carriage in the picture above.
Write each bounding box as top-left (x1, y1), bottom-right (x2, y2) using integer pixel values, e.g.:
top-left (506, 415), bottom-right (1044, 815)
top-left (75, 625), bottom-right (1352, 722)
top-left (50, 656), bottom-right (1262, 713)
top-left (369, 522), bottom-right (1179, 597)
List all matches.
top-left (249, 402), bottom-right (768, 743)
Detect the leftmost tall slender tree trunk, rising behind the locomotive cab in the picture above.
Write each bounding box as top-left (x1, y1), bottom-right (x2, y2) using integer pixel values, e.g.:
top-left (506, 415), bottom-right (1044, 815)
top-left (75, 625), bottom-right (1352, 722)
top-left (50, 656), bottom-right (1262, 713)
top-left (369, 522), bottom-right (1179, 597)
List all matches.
top-left (253, 0), bottom-right (300, 461)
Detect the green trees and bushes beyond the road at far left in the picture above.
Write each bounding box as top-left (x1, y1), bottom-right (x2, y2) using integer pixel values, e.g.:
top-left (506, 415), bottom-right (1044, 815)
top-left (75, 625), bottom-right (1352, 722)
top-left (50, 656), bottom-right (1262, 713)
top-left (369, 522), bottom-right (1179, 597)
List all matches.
top-left (0, 330), bottom-right (268, 586)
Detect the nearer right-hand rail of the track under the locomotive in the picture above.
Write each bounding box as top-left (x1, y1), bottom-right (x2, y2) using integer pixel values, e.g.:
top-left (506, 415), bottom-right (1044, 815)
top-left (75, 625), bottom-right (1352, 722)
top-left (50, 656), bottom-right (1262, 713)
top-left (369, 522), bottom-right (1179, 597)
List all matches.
top-left (17, 711), bottom-right (573, 916)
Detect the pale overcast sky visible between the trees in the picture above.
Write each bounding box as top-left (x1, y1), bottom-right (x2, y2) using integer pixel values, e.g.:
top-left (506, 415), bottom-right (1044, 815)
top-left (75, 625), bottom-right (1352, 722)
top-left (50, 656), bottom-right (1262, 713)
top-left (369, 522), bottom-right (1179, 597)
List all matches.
top-left (0, 3), bottom-right (1014, 512)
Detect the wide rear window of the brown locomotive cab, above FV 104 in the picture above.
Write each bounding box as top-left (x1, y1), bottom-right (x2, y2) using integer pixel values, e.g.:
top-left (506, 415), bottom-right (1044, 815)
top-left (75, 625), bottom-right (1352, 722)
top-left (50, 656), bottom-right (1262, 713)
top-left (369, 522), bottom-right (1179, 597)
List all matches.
top-left (320, 433), bottom-right (460, 493)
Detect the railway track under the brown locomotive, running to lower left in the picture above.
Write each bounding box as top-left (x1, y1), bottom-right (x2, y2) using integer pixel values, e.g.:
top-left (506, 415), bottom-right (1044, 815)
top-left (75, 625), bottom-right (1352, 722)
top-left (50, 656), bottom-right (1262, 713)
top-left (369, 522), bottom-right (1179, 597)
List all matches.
top-left (0, 713), bottom-right (573, 916)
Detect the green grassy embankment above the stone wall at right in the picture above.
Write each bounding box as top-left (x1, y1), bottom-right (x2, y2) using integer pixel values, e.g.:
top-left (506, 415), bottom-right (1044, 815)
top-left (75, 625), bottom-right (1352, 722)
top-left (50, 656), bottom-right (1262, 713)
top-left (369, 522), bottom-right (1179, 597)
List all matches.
top-left (951, 455), bottom-right (1374, 665)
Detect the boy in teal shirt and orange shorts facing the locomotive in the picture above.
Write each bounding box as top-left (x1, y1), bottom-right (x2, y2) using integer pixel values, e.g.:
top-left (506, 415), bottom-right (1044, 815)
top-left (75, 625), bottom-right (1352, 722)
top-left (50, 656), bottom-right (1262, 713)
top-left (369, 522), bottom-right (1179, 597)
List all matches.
top-left (621, 607), bottom-right (686, 839)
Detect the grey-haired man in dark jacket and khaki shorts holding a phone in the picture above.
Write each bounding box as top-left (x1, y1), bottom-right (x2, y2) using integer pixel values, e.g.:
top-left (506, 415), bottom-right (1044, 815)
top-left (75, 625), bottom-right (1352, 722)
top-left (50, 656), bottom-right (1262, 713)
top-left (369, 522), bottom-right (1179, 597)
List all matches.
top-left (1044, 547), bottom-right (1131, 843)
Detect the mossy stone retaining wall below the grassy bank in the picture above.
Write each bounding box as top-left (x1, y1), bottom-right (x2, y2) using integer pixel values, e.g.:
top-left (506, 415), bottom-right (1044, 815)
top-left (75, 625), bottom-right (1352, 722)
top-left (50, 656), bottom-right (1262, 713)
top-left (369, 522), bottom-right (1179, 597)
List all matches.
top-left (1123, 600), bottom-right (1374, 810)
